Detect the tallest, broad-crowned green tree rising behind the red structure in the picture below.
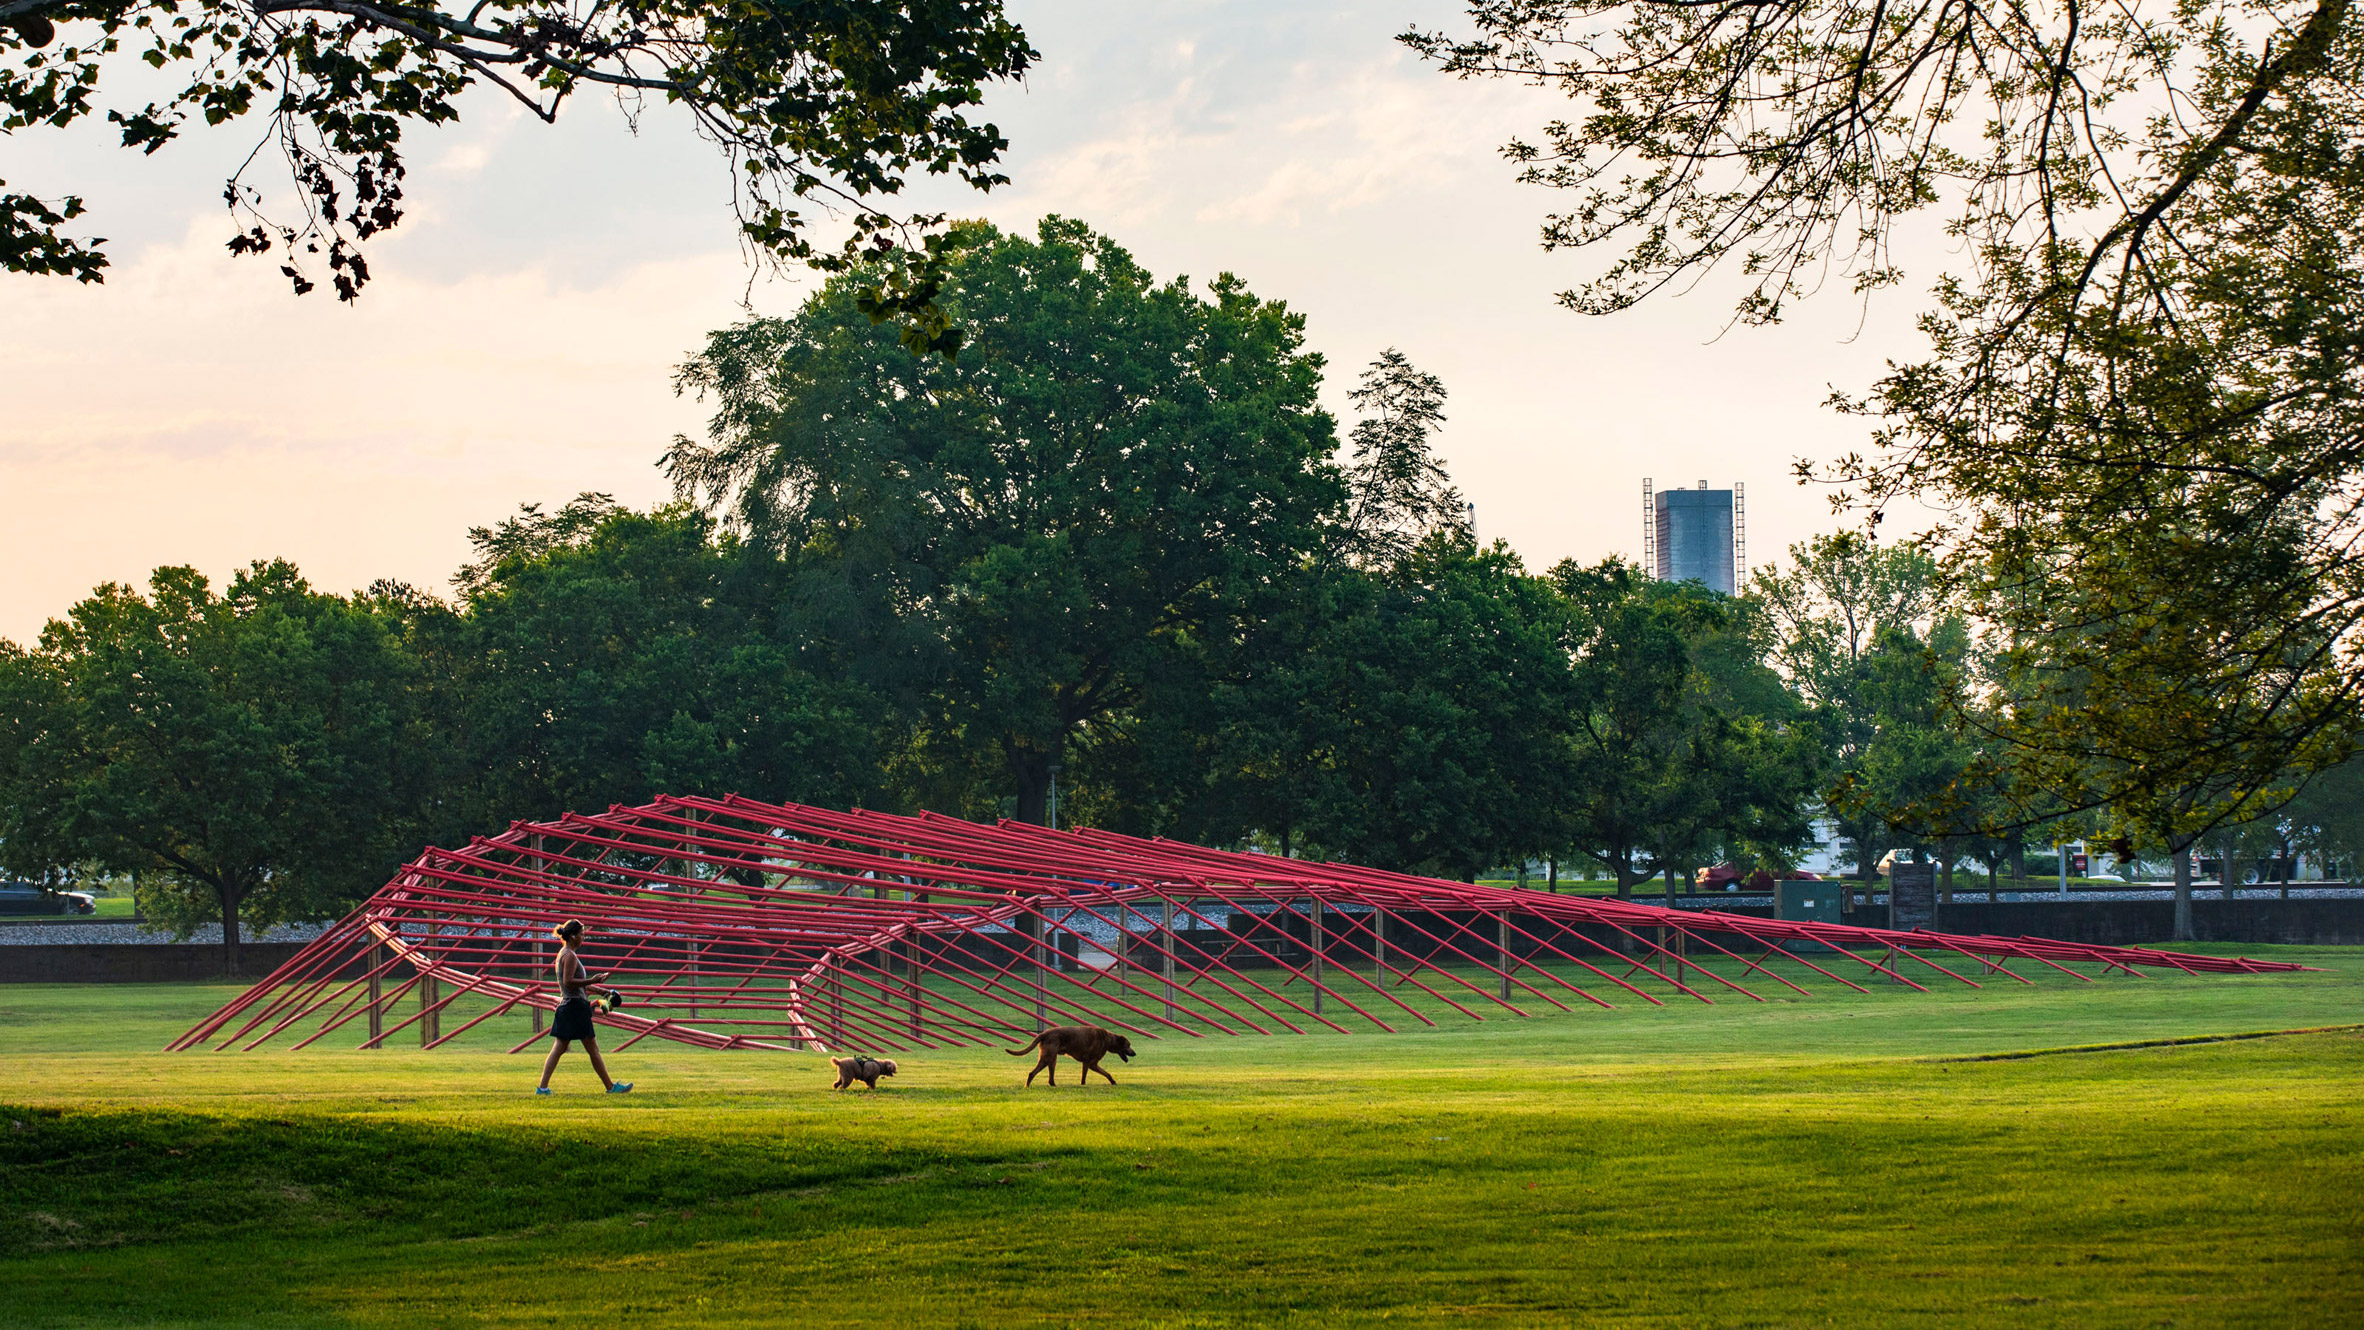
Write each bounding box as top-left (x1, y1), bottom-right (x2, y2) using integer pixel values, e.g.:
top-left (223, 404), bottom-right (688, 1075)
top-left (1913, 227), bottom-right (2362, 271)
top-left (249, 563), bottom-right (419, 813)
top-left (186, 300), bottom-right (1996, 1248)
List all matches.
top-left (667, 217), bottom-right (1343, 822)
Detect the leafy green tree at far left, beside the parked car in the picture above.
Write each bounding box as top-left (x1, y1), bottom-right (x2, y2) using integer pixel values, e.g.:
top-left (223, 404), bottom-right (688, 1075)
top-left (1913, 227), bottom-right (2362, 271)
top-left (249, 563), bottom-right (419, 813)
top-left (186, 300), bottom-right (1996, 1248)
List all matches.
top-left (0, 562), bottom-right (409, 973)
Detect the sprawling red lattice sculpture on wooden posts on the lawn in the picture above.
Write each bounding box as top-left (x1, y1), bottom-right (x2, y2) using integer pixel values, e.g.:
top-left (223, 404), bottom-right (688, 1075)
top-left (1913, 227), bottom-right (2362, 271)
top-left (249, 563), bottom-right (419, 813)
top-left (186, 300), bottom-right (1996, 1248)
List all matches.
top-left (173, 796), bottom-right (2305, 1051)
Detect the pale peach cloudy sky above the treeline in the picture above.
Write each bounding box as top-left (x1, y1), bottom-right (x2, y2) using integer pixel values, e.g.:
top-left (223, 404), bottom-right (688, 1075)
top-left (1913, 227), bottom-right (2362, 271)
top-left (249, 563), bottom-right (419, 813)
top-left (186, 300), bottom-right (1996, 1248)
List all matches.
top-left (0, 0), bottom-right (1934, 643)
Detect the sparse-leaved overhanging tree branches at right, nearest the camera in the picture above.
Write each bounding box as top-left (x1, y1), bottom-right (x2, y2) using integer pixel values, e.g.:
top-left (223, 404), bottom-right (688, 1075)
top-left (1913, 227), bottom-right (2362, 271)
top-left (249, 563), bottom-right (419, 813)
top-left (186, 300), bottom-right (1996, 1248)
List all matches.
top-left (1404, 0), bottom-right (2364, 817)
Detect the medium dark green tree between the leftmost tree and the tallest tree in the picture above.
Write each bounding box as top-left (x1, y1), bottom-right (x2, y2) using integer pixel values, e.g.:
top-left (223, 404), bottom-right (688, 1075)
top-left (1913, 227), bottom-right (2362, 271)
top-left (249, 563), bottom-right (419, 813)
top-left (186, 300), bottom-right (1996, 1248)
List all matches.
top-left (449, 494), bottom-right (894, 827)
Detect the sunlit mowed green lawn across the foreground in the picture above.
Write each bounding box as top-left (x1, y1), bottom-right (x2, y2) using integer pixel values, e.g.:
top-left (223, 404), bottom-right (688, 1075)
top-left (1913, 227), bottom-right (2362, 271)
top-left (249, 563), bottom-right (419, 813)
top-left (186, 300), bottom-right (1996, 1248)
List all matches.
top-left (0, 947), bottom-right (2364, 1325)
